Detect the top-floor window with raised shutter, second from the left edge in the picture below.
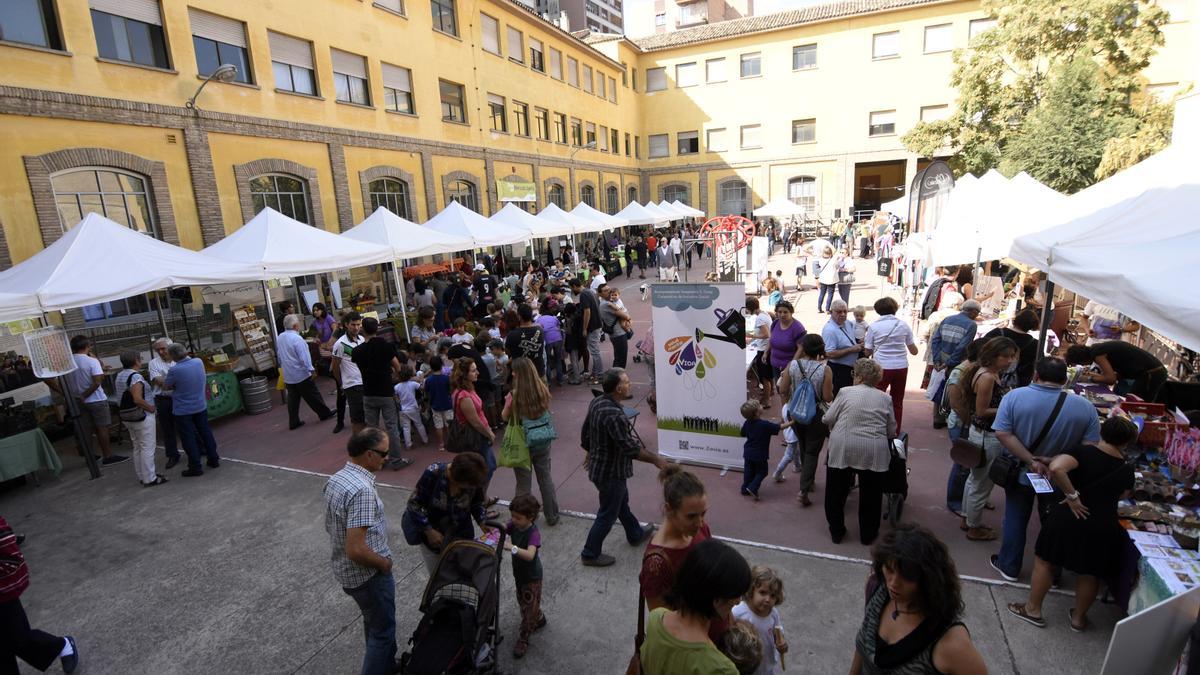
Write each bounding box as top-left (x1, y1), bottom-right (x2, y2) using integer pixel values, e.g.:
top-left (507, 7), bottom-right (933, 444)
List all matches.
top-left (90, 0), bottom-right (170, 68)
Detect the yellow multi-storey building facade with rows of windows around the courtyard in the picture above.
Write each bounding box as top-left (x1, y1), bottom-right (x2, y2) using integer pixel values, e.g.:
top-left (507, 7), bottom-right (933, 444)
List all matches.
top-left (0, 0), bottom-right (1196, 281)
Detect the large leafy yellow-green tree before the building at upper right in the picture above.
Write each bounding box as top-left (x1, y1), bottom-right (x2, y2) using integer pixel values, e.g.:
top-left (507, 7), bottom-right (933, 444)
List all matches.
top-left (904, 0), bottom-right (1168, 191)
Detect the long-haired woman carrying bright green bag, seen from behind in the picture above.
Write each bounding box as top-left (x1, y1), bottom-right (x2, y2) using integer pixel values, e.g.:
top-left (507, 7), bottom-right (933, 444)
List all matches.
top-left (500, 357), bottom-right (558, 526)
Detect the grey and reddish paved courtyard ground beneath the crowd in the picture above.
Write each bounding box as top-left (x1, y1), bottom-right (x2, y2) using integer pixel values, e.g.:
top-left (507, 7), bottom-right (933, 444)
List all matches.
top-left (0, 248), bottom-right (1120, 674)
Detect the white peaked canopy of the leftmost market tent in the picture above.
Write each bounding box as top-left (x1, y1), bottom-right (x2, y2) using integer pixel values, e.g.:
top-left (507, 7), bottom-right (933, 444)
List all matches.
top-left (0, 213), bottom-right (262, 318)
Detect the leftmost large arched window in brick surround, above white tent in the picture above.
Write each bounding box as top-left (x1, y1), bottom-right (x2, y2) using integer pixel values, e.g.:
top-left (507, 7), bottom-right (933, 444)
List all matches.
top-left (50, 167), bottom-right (162, 239)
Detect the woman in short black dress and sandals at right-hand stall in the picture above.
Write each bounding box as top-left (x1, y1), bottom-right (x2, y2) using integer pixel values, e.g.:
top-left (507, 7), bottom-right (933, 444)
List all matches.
top-left (1008, 417), bottom-right (1138, 633)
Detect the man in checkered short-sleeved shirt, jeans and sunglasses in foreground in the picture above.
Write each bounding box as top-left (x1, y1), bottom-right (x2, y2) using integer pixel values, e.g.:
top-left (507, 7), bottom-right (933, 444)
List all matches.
top-left (324, 426), bottom-right (396, 675)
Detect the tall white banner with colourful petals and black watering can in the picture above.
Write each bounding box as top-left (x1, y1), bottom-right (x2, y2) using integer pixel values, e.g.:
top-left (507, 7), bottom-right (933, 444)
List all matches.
top-left (652, 283), bottom-right (746, 467)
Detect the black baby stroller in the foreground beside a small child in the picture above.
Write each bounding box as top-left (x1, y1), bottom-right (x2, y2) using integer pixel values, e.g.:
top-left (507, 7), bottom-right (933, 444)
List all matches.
top-left (400, 521), bottom-right (504, 675)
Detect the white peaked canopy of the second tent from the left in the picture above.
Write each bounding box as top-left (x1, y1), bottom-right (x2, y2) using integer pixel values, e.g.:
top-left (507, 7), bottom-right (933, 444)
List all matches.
top-left (202, 208), bottom-right (396, 276)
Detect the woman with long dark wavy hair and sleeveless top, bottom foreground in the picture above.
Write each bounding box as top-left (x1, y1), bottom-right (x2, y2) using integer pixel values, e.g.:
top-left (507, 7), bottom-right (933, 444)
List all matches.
top-left (850, 525), bottom-right (988, 675)
